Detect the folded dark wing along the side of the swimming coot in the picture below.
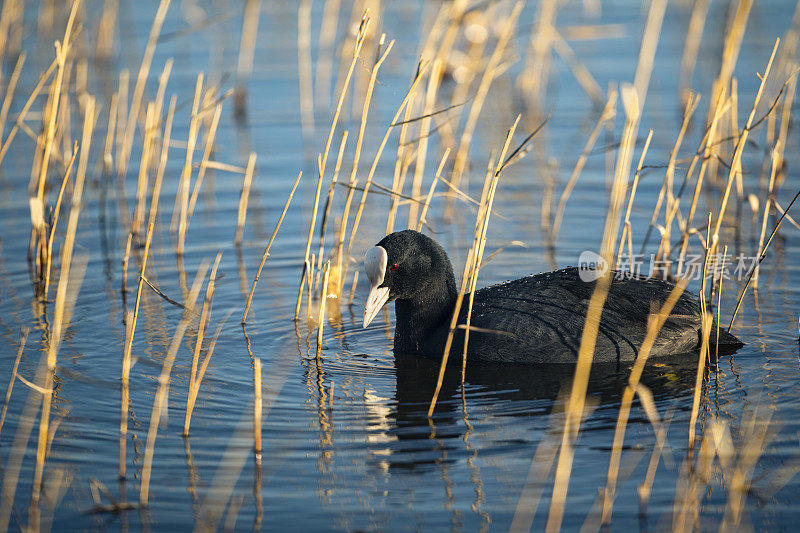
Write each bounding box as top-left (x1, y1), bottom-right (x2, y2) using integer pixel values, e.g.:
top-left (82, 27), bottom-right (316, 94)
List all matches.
top-left (462, 268), bottom-right (700, 362)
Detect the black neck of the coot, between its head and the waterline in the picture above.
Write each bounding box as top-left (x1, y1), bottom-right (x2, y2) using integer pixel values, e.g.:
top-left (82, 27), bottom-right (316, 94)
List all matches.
top-left (394, 270), bottom-right (458, 357)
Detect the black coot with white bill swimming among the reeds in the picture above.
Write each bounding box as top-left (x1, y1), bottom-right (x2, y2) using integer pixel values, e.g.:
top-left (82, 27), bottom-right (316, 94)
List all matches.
top-left (364, 230), bottom-right (742, 363)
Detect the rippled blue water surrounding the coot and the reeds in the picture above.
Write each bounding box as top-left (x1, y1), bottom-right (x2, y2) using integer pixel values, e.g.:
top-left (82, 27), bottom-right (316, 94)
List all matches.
top-left (0, 1), bottom-right (800, 531)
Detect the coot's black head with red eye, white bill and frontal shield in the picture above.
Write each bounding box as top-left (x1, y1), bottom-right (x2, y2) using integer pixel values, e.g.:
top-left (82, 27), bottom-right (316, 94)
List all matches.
top-left (364, 229), bottom-right (455, 327)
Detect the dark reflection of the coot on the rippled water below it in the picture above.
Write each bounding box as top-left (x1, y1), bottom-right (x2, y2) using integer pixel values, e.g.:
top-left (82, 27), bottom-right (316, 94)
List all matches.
top-left (365, 354), bottom-right (697, 469)
